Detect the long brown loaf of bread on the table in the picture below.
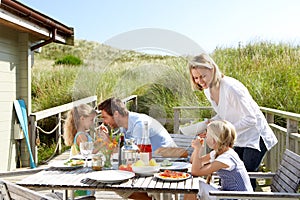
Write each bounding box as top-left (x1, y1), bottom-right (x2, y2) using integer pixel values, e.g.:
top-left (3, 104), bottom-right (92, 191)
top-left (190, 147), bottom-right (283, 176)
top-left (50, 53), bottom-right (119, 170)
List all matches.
top-left (154, 147), bottom-right (188, 158)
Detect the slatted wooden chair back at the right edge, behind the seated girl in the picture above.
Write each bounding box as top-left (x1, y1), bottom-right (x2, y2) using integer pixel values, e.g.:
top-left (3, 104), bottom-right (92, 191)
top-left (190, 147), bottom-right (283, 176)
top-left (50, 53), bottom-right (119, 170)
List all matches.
top-left (271, 149), bottom-right (300, 193)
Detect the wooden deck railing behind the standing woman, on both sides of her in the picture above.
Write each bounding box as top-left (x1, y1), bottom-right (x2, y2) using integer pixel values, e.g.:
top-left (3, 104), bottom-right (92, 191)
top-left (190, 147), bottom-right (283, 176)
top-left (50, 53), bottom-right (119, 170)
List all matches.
top-left (173, 106), bottom-right (300, 172)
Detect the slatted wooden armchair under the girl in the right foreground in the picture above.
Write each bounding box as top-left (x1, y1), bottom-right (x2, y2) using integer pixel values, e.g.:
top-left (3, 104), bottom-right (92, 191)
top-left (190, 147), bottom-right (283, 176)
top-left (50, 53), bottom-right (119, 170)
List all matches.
top-left (209, 149), bottom-right (300, 199)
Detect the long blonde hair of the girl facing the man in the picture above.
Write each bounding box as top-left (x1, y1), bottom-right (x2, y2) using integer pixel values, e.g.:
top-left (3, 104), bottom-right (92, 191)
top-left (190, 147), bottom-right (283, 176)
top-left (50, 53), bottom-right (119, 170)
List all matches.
top-left (63, 104), bottom-right (97, 146)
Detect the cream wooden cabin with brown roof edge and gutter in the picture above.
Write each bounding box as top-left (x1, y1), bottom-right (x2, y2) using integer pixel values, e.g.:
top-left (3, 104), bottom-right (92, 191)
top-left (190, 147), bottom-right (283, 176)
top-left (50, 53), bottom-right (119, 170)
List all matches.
top-left (0, 0), bottom-right (74, 171)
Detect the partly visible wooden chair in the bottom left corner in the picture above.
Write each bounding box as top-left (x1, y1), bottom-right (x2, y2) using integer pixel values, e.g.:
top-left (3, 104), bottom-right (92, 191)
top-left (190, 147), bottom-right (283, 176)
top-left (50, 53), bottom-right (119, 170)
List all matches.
top-left (0, 180), bottom-right (54, 200)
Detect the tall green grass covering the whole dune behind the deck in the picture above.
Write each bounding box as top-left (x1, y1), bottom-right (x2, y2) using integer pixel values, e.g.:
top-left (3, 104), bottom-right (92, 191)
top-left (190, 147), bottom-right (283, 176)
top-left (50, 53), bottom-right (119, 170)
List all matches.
top-left (32, 40), bottom-right (300, 162)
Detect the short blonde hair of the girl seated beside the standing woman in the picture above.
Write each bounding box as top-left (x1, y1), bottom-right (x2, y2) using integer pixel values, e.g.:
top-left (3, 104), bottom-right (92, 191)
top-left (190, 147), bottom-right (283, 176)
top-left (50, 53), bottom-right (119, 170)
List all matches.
top-left (207, 120), bottom-right (236, 157)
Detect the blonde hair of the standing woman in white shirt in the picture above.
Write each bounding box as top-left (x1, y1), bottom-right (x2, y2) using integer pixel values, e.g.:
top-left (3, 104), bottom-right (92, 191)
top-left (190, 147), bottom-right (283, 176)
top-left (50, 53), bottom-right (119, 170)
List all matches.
top-left (188, 53), bottom-right (224, 90)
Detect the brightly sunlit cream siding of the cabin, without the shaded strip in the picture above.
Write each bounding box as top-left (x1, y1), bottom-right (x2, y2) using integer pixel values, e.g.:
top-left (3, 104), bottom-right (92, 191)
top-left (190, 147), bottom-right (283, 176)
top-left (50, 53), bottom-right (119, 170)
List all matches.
top-left (0, 26), bottom-right (18, 170)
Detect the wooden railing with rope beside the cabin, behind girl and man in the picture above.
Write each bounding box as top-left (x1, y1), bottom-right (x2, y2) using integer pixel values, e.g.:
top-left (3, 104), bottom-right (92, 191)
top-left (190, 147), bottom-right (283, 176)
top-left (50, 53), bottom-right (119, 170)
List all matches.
top-left (29, 95), bottom-right (137, 164)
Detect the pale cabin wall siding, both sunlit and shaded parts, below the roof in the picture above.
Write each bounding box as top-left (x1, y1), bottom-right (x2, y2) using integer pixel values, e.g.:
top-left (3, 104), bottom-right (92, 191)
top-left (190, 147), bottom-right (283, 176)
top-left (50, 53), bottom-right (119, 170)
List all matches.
top-left (0, 25), bottom-right (31, 171)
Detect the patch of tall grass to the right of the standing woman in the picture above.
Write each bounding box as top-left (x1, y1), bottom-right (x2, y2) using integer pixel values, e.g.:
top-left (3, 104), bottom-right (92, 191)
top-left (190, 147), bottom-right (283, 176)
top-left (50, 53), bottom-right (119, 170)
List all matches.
top-left (213, 42), bottom-right (300, 113)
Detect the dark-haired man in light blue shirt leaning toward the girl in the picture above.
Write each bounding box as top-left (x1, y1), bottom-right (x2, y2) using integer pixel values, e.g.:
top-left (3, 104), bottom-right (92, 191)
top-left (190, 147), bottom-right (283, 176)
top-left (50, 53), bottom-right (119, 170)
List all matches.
top-left (98, 97), bottom-right (177, 152)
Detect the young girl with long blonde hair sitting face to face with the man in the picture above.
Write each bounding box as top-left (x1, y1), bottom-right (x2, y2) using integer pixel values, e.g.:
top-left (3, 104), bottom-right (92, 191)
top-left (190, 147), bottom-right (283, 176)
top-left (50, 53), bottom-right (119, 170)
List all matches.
top-left (64, 104), bottom-right (97, 157)
